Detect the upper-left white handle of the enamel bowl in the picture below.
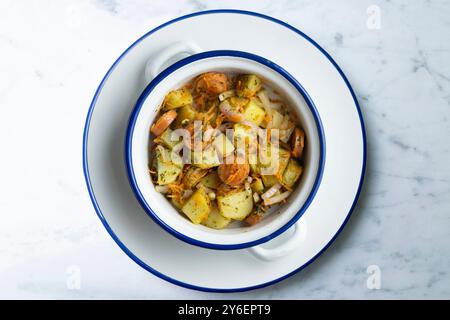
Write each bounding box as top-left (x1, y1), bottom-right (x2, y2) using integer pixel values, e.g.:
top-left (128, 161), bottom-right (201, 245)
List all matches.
top-left (144, 42), bottom-right (203, 83)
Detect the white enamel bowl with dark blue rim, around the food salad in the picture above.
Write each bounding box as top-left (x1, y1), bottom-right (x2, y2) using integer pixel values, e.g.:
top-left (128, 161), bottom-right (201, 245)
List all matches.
top-left (125, 49), bottom-right (325, 249)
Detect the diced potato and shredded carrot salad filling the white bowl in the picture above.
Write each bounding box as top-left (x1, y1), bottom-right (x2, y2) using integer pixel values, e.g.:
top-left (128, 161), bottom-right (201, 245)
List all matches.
top-left (149, 72), bottom-right (306, 229)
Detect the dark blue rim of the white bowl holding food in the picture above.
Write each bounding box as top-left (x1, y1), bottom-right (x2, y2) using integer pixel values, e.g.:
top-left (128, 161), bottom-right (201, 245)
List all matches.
top-left (125, 50), bottom-right (325, 250)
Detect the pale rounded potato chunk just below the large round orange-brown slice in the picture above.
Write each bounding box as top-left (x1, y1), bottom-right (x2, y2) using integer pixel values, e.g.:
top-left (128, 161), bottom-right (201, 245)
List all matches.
top-left (217, 189), bottom-right (253, 220)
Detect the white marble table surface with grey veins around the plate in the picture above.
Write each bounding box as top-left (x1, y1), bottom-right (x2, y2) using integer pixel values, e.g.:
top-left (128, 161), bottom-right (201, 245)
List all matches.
top-left (0, 0), bottom-right (450, 299)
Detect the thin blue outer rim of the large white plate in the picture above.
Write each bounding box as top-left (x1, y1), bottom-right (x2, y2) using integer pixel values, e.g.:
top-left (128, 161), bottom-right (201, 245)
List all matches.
top-left (82, 9), bottom-right (367, 293)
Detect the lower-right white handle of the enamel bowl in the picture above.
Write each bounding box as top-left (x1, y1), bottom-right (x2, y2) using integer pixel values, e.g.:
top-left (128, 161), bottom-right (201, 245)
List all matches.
top-left (248, 220), bottom-right (307, 261)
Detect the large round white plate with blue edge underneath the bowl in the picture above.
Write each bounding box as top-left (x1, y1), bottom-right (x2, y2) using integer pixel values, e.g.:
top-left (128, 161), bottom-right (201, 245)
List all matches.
top-left (83, 10), bottom-right (366, 292)
